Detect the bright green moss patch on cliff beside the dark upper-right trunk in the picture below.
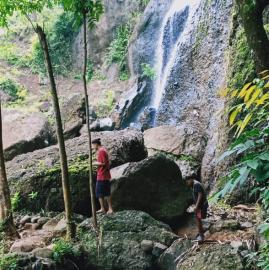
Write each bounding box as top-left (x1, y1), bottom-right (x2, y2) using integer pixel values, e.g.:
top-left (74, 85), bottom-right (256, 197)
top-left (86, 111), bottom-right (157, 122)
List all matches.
top-left (229, 28), bottom-right (255, 88)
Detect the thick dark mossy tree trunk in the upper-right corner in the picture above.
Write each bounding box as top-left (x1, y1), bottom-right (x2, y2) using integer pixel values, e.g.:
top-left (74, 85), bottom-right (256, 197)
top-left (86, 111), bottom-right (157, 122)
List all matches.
top-left (236, 0), bottom-right (269, 73)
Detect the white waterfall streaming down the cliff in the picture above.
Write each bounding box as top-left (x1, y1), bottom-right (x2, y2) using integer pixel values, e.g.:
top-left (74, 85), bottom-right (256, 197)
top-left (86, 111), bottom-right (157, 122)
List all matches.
top-left (151, 0), bottom-right (201, 111)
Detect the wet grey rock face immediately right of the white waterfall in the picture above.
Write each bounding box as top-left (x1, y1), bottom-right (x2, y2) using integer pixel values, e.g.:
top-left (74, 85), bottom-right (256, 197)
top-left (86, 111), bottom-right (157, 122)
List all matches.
top-left (157, 0), bottom-right (232, 184)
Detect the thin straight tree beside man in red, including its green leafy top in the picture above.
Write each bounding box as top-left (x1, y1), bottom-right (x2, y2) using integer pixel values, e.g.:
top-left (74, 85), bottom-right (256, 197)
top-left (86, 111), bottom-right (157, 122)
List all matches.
top-left (60, 0), bottom-right (103, 228)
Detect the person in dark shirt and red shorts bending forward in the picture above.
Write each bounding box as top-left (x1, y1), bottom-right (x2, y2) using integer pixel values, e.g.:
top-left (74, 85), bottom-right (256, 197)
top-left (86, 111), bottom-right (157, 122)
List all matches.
top-left (186, 176), bottom-right (208, 242)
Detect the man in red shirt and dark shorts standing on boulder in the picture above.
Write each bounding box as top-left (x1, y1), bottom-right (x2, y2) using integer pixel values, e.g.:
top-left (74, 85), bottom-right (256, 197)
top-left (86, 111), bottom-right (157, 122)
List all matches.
top-left (92, 139), bottom-right (113, 214)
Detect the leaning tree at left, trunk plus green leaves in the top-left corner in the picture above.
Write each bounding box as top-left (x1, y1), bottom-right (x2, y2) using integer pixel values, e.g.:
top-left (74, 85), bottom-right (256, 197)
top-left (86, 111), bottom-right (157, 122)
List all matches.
top-left (0, 0), bottom-right (75, 238)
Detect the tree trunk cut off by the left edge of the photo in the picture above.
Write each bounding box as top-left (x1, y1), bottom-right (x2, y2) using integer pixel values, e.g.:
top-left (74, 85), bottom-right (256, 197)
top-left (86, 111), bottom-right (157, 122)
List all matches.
top-left (0, 99), bottom-right (19, 237)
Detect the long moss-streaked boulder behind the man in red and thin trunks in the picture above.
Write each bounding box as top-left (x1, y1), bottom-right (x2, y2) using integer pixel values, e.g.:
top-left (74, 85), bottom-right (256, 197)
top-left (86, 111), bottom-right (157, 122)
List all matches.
top-left (6, 129), bottom-right (146, 214)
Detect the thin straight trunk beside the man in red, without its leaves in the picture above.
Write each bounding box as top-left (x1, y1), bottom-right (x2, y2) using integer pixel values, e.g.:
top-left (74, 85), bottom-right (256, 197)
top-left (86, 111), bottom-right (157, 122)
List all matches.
top-left (83, 11), bottom-right (97, 229)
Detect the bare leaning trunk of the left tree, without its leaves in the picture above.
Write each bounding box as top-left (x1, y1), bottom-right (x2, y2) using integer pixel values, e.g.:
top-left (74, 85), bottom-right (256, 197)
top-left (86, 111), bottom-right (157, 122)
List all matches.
top-left (35, 26), bottom-right (76, 239)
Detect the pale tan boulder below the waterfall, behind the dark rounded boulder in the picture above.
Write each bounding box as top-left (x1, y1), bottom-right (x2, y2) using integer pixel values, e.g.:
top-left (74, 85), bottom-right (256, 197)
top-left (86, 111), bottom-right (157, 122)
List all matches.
top-left (144, 125), bottom-right (203, 178)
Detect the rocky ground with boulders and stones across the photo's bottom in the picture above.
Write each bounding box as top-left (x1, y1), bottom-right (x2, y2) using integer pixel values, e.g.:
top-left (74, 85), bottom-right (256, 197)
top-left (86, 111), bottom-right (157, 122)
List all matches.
top-left (0, 205), bottom-right (259, 270)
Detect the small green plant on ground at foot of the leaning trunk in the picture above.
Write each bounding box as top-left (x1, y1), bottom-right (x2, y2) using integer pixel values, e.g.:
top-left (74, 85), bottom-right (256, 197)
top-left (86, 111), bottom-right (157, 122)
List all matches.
top-left (52, 238), bottom-right (80, 263)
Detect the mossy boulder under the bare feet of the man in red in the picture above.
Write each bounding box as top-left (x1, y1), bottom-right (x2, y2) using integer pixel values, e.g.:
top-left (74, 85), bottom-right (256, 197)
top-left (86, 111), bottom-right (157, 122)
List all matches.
top-left (79, 211), bottom-right (178, 270)
